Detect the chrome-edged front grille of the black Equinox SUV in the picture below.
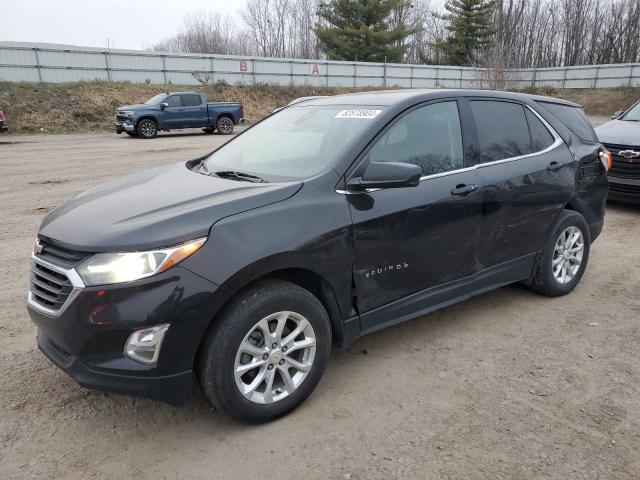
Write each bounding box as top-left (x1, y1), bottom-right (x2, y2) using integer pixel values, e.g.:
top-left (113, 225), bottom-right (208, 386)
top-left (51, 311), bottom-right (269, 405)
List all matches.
top-left (28, 255), bottom-right (84, 316)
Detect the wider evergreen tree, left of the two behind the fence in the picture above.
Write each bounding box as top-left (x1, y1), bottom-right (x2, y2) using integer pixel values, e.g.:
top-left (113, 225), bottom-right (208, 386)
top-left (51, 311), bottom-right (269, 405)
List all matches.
top-left (315, 0), bottom-right (415, 62)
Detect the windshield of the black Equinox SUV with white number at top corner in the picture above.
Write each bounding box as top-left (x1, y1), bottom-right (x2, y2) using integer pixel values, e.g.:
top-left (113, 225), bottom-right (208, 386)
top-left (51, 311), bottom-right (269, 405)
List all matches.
top-left (203, 105), bottom-right (383, 180)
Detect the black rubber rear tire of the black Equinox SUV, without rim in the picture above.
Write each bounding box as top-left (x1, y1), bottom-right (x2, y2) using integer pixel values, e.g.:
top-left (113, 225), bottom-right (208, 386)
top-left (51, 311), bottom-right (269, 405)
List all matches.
top-left (530, 210), bottom-right (591, 297)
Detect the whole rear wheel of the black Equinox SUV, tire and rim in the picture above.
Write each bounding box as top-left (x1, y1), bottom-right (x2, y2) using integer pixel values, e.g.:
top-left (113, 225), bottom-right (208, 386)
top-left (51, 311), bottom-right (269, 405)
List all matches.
top-left (531, 210), bottom-right (591, 297)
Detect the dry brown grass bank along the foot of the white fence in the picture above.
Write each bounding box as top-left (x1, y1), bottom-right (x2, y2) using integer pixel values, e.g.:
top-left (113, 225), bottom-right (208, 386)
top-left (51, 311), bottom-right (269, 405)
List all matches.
top-left (0, 81), bottom-right (640, 133)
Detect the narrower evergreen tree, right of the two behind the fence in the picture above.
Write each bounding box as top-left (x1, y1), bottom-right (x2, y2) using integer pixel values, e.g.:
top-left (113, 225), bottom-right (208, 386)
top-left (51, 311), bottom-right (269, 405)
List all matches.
top-left (434, 0), bottom-right (497, 65)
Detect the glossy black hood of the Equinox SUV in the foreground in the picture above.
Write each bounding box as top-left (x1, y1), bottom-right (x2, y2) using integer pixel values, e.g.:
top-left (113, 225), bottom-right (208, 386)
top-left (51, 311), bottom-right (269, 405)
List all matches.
top-left (39, 163), bottom-right (302, 252)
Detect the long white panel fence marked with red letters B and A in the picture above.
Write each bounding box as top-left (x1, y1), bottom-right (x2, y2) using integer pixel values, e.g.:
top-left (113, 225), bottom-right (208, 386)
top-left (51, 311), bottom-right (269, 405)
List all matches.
top-left (0, 42), bottom-right (640, 88)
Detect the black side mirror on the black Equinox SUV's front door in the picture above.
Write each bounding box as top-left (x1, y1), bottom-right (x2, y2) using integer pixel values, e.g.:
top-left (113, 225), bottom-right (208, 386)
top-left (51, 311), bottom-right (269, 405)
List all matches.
top-left (347, 162), bottom-right (422, 191)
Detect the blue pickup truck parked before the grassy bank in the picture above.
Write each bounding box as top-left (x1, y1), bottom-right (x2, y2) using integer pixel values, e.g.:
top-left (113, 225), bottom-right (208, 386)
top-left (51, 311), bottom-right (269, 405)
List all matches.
top-left (115, 92), bottom-right (244, 138)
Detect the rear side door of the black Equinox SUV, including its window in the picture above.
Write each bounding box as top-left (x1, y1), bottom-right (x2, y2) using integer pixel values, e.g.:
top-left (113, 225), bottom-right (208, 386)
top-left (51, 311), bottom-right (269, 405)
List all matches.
top-left (465, 99), bottom-right (574, 280)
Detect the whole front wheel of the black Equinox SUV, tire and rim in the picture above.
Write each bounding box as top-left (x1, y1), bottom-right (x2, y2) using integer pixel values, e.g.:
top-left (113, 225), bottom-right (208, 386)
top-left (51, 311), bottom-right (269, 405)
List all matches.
top-left (198, 280), bottom-right (331, 423)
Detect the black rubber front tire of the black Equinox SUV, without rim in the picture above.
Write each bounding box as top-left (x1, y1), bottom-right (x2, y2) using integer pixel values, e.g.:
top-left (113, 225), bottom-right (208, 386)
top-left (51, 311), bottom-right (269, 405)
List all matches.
top-left (197, 280), bottom-right (331, 423)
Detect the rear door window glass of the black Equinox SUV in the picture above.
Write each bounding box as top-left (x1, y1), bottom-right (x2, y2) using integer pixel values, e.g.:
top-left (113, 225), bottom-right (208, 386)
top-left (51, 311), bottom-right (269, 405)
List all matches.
top-left (471, 100), bottom-right (532, 163)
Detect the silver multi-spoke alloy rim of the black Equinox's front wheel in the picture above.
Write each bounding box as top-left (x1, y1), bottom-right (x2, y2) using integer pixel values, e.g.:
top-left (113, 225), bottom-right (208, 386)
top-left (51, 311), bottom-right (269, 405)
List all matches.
top-left (233, 312), bottom-right (316, 404)
